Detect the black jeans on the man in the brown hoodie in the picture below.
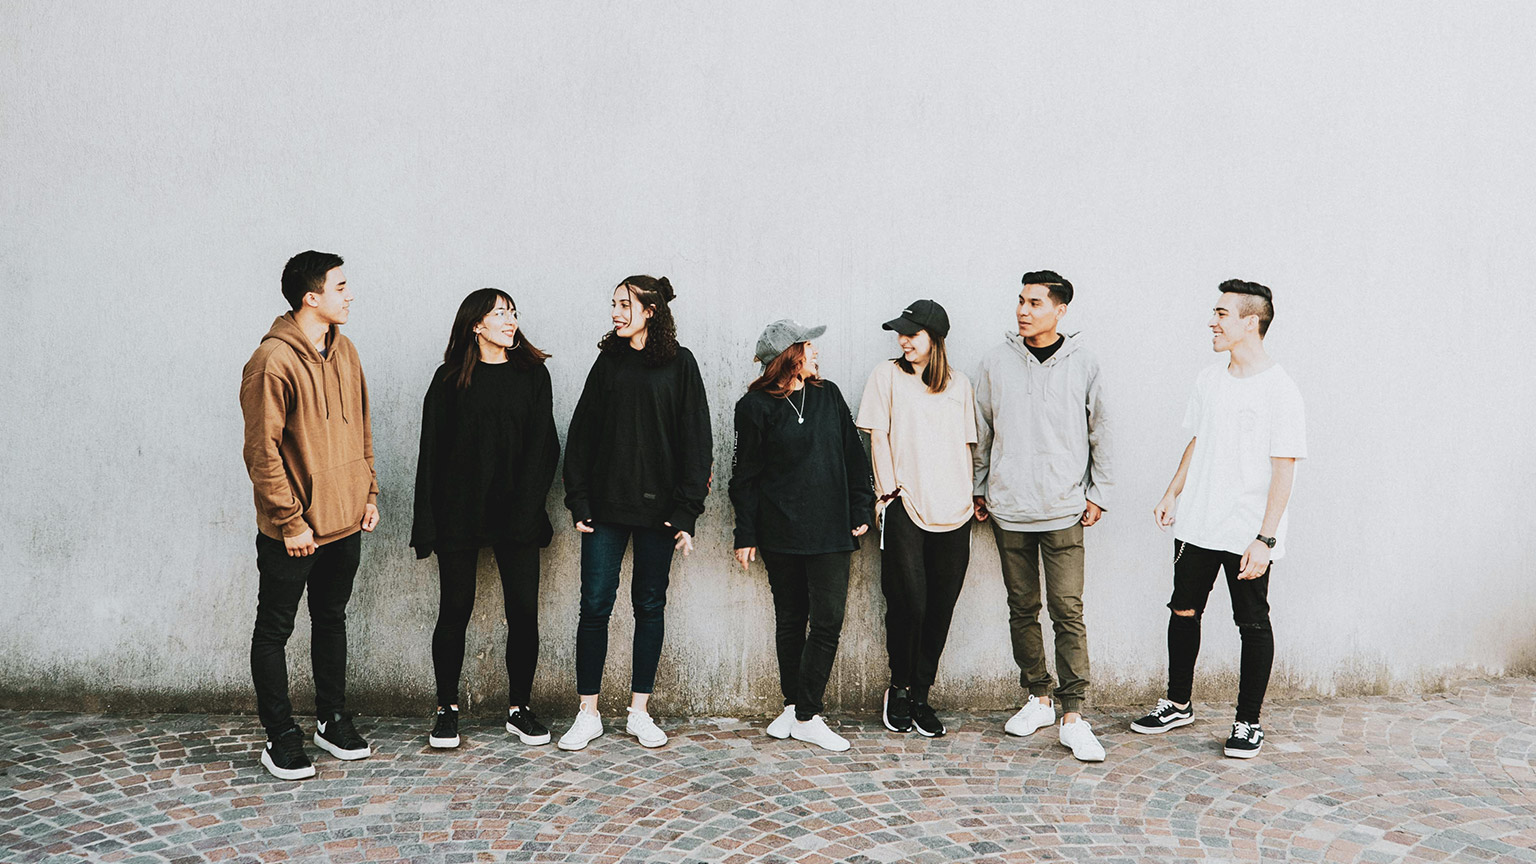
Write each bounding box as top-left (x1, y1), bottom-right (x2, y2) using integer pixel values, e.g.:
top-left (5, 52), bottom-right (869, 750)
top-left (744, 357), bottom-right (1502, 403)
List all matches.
top-left (250, 533), bottom-right (362, 735)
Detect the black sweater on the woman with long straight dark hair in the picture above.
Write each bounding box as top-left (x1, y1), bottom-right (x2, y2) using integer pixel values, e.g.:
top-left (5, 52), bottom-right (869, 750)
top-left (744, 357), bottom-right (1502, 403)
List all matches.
top-left (410, 363), bottom-right (561, 558)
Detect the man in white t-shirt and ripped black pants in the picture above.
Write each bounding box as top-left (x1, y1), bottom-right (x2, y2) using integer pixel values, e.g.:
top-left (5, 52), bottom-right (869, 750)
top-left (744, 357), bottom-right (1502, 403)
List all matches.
top-left (1130, 280), bottom-right (1307, 759)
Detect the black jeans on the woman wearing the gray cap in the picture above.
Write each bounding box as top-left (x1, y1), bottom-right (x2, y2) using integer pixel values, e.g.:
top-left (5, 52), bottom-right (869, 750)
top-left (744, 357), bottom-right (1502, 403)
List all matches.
top-left (763, 552), bottom-right (852, 721)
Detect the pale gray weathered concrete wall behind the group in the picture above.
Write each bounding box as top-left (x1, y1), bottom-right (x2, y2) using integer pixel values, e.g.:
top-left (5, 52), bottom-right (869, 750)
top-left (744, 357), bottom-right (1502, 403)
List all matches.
top-left (0, 0), bottom-right (1536, 713)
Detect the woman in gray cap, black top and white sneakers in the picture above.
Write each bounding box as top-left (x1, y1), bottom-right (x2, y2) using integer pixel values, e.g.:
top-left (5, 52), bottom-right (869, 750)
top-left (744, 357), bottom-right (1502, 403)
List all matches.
top-left (730, 318), bottom-right (878, 752)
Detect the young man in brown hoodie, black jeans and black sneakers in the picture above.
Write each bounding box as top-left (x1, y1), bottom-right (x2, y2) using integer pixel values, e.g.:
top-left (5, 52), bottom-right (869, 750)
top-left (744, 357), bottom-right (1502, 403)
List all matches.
top-left (240, 251), bottom-right (379, 779)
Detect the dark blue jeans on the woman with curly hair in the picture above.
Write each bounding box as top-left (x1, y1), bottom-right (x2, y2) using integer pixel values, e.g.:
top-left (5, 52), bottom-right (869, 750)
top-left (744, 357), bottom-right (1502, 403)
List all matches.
top-left (576, 521), bottom-right (676, 696)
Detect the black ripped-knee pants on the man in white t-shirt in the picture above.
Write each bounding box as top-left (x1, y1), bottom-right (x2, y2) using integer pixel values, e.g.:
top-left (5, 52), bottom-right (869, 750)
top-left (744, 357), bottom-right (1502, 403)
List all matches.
top-left (1167, 540), bottom-right (1275, 723)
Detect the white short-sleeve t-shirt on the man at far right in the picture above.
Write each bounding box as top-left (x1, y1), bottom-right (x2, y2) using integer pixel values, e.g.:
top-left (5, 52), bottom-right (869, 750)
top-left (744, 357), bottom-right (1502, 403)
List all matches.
top-left (1174, 361), bottom-right (1307, 561)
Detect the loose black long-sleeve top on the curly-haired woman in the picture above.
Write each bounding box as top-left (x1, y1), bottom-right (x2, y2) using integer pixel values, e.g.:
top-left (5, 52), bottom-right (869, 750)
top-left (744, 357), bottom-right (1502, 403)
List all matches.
top-left (565, 344), bottom-right (714, 533)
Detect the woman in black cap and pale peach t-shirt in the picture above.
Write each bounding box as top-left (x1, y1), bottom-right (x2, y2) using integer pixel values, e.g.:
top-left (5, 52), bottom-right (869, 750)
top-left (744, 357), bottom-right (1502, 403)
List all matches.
top-left (859, 300), bottom-right (975, 738)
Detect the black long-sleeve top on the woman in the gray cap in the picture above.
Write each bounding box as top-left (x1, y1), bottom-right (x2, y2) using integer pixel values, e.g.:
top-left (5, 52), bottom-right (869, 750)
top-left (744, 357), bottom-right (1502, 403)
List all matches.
top-left (730, 381), bottom-right (874, 555)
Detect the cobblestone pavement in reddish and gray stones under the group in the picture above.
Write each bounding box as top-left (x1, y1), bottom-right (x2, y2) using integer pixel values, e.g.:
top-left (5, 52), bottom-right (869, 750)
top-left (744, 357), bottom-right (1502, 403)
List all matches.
top-left (0, 678), bottom-right (1536, 864)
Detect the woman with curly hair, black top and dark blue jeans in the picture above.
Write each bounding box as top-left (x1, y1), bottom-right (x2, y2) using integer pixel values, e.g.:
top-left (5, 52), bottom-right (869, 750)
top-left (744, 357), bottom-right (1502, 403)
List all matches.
top-left (559, 275), bottom-right (714, 750)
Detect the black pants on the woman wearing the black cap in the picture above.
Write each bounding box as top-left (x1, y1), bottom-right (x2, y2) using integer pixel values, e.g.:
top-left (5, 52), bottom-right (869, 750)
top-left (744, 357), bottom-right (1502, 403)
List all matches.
top-left (880, 500), bottom-right (971, 703)
